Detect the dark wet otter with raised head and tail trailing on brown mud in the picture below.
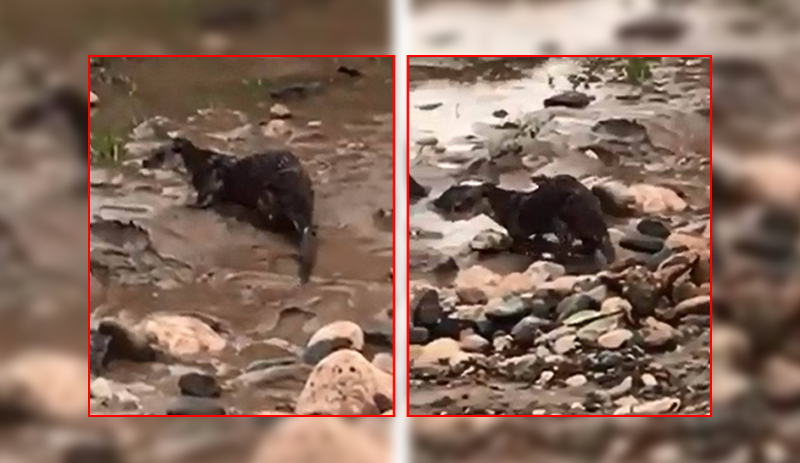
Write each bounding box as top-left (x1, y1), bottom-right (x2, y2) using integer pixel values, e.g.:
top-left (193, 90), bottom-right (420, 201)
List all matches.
top-left (172, 138), bottom-right (317, 283)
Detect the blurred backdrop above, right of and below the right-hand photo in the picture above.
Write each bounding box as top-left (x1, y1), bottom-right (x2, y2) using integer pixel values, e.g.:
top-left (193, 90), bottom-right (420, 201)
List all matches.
top-left (412, 0), bottom-right (800, 462)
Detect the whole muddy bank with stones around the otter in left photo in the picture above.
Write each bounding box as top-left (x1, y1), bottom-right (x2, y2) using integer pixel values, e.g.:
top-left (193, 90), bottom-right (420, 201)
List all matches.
top-left (90, 58), bottom-right (393, 415)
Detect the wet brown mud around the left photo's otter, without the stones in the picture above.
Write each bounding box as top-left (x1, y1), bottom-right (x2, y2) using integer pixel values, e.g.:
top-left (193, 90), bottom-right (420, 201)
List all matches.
top-left (90, 58), bottom-right (393, 413)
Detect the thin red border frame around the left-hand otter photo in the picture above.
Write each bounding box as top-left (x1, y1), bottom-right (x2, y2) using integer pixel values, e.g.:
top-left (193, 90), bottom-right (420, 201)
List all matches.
top-left (86, 55), bottom-right (397, 418)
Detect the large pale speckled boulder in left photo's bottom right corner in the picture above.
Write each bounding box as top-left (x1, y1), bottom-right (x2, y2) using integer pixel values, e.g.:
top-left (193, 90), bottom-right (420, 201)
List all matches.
top-left (295, 350), bottom-right (394, 415)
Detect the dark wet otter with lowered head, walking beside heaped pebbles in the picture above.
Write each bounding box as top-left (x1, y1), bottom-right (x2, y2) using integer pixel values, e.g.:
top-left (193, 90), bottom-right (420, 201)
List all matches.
top-left (434, 175), bottom-right (615, 262)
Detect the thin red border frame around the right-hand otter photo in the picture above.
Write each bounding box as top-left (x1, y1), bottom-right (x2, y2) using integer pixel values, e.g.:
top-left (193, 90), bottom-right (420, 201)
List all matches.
top-left (406, 55), bottom-right (714, 418)
